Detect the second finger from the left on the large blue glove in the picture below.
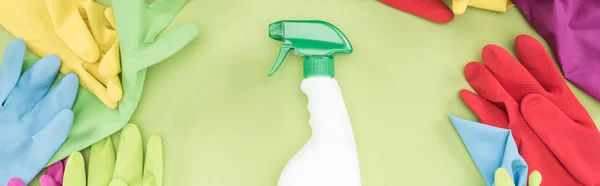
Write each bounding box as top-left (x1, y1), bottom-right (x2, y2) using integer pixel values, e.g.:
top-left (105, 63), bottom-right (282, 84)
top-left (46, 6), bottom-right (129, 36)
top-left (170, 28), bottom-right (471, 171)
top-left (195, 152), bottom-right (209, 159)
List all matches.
top-left (5, 55), bottom-right (60, 116)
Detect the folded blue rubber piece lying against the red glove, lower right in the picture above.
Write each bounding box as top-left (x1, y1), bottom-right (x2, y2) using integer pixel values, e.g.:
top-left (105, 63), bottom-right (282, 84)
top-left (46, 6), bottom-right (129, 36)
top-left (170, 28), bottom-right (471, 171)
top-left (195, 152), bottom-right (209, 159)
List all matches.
top-left (448, 115), bottom-right (528, 186)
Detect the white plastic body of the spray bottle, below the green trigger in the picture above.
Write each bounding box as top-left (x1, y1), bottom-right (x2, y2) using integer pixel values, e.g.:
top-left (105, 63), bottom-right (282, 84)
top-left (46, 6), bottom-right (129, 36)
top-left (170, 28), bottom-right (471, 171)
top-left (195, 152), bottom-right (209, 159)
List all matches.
top-left (278, 76), bottom-right (361, 186)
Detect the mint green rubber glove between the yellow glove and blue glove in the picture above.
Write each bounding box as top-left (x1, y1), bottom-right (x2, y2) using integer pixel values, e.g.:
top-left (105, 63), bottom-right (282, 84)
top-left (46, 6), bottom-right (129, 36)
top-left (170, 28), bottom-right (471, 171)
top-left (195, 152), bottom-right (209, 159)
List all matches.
top-left (50, 0), bottom-right (198, 163)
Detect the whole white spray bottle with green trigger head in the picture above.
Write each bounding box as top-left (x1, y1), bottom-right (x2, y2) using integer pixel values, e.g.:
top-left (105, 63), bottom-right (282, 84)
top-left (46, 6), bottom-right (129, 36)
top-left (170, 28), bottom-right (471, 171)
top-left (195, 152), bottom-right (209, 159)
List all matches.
top-left (269, 20), bottom-right (361, 186)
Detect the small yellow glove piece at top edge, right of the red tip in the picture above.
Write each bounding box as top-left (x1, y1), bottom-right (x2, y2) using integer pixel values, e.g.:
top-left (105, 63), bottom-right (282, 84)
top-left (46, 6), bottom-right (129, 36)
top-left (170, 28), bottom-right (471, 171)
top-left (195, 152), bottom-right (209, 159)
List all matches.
top-left (452, 0), bottom-right (515, 14)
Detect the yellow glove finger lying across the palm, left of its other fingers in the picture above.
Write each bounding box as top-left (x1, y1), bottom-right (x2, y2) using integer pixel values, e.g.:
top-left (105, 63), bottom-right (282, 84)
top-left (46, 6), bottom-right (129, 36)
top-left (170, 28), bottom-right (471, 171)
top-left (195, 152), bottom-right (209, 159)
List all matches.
top-left (46, 0), bottom-right (100, 63)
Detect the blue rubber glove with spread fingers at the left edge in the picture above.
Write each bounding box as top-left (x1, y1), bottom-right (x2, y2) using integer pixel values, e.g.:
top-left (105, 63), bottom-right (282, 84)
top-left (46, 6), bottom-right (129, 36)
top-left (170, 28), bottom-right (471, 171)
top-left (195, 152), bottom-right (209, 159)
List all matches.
top-left (0, 39), bottom-right (79, 185)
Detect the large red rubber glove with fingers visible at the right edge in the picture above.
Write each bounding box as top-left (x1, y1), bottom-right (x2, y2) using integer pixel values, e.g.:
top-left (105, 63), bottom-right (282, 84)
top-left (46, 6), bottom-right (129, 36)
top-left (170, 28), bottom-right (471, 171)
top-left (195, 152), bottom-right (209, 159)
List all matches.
top-left (460, 35), bottom-right (600, 186)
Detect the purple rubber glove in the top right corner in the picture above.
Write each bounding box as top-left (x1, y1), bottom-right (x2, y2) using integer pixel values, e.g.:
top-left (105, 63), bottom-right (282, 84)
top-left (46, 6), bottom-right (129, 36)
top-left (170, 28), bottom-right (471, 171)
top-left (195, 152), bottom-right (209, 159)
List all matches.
top-left (513, 0), bottom-right (600, 100)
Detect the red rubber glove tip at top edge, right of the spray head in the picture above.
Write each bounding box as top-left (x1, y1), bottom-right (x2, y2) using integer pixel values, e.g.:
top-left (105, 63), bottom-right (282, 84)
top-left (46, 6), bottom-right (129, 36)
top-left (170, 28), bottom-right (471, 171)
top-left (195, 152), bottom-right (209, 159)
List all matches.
top-left (380, 0), bottom-right (454, 23)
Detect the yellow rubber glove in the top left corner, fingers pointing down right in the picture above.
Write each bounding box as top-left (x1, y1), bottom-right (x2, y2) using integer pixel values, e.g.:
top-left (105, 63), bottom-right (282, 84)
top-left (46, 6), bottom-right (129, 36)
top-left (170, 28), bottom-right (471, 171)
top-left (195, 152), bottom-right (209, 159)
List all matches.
top-left (0, 0), bottom-right (123, 109)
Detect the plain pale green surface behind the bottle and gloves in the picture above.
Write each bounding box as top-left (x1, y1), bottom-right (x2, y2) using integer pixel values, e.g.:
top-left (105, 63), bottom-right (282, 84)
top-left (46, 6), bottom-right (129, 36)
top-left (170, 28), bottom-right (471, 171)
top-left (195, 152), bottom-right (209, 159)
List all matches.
top-left (0, 0), bottom-right (600, 186)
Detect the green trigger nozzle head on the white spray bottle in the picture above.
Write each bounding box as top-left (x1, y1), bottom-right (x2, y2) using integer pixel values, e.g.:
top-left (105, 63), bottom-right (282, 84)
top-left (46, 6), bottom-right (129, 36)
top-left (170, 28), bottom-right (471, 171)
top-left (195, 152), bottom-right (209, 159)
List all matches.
top-left (269, 20), bottom-right (352, 77)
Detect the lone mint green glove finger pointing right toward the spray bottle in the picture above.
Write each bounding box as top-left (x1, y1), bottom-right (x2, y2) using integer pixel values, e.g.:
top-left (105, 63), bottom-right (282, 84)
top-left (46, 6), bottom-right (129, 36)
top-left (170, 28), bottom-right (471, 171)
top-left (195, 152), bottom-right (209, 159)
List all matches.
top-left (132, 24), bottom-right (198, 74)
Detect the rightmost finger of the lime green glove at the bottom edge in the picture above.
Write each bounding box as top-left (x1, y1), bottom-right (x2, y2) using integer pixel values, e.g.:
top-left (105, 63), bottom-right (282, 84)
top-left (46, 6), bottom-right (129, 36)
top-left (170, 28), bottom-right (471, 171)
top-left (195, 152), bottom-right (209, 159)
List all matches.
top-left (143, 136), bottom-right (163, 186)
